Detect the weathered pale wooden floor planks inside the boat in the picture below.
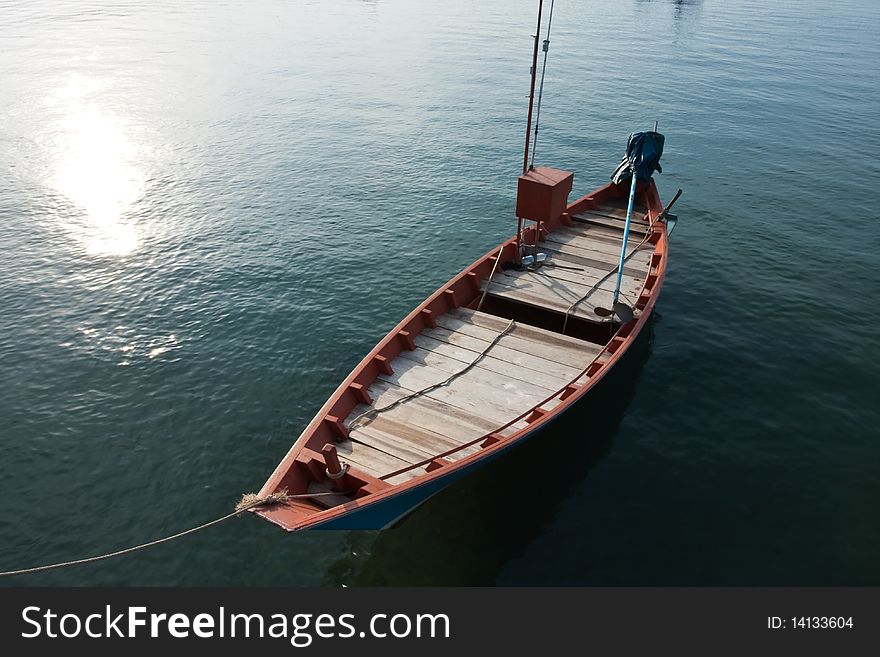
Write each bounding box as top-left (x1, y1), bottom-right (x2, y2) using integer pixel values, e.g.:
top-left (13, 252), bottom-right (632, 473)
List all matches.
top-left (336, 204), bottom-right (653, 484)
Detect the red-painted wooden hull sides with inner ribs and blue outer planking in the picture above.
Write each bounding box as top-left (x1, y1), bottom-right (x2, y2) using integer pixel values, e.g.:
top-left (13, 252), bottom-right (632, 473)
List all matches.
top-left (255, 181), bottom-right (667, 531)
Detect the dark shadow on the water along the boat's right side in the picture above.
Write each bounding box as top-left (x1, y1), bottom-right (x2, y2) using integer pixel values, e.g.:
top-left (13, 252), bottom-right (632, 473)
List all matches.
top-left (328, 314), bottom-right (656, 586)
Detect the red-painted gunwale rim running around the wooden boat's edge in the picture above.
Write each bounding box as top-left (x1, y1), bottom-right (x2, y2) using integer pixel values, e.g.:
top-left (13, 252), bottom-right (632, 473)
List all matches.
top-left (252, 179), bottom-right (668, 531)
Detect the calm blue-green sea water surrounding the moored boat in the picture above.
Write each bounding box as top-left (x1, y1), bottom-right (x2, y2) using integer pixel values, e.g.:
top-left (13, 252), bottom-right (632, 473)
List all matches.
top-left (0, 0), bottom-right (880, 586)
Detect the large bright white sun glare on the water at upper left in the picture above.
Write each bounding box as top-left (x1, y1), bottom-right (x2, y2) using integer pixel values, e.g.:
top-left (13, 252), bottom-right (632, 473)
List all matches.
top-left (53, 75), bottom-right (145, 256)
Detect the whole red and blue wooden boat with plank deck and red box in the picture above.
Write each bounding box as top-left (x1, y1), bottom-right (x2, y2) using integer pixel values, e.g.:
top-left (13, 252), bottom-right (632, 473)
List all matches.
top-left (254, 3), bottom-right (677, 531)
